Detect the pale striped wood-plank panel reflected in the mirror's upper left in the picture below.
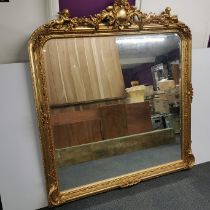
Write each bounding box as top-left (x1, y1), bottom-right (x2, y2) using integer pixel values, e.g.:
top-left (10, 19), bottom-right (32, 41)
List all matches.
top-left (44, 37), bottom-right (125, 105)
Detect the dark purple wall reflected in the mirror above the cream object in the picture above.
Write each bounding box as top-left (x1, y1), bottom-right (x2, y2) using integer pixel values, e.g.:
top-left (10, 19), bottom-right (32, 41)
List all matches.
top-left (122, 63), bottom-right (154, 88)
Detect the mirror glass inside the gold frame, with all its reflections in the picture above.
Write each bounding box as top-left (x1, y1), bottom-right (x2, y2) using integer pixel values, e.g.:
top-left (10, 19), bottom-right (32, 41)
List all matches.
top-left (43, 33), bottom-right (181, 191)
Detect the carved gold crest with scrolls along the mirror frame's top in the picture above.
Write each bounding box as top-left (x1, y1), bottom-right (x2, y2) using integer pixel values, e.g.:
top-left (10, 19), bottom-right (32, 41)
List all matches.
top-left (48, 0), bottom-right (185, 31)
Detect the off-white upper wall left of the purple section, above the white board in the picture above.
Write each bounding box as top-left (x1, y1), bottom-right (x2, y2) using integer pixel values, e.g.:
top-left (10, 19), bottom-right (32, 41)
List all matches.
top-left (0, 0), bottom-right (48, 63)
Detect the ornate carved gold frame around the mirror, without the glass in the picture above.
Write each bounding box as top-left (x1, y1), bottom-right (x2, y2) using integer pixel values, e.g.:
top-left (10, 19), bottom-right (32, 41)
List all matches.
top-left (28, 0), bottom-right (194, 206)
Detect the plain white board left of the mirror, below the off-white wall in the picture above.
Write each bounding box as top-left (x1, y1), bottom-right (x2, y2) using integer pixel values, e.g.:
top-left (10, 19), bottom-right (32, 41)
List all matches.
top-left (0, 63), bottom-right (47, 210)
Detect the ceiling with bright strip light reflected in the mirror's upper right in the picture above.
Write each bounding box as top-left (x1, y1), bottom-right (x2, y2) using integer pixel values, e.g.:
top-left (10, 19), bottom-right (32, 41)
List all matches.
top-left (116, 34), bottom-right (180, 66)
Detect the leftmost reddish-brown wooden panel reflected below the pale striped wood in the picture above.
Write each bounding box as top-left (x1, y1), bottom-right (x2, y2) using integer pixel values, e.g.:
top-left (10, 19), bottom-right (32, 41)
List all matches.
top-left (51, 109), bottom-right (102, 148)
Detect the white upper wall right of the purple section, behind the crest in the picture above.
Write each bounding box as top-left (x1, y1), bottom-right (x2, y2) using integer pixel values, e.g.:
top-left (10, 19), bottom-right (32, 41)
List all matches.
top-left (141, 0), bottom-right (210, 48)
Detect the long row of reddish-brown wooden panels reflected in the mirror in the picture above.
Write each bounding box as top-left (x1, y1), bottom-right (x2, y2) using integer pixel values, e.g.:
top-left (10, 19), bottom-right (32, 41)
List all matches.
top-left (51, 102), bottom-right (152, 148)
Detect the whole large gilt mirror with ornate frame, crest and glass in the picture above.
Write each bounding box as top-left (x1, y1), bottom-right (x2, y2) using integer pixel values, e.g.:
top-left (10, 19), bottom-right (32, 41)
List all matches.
top-left (29, 0), bottom-right (194, 206)
